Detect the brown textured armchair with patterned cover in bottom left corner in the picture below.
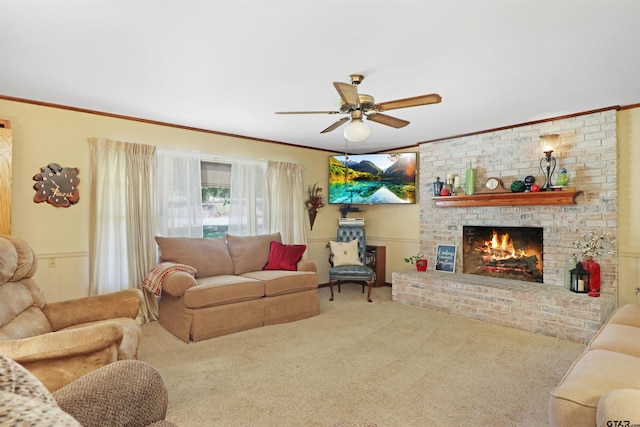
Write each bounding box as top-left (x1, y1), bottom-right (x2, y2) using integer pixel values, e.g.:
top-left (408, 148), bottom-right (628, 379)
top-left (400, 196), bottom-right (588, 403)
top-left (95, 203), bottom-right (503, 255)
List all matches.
top-left (0, 355), bottom-right (175, 427)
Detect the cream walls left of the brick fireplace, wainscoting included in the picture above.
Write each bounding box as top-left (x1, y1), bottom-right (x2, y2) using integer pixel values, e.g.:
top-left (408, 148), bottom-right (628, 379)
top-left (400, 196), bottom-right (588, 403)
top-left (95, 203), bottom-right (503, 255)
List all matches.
top-left (0, 99), bottom-right (420, 300)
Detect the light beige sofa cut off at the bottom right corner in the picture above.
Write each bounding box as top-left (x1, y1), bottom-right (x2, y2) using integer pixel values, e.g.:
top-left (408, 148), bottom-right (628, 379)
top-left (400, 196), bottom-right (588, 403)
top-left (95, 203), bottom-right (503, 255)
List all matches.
top-left (549, 304), bottom-right (640, 427)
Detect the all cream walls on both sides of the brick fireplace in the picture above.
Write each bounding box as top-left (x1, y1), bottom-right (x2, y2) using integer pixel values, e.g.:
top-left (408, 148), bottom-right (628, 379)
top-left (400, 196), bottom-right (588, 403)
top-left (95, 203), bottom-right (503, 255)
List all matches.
top-left (6, 99), bottom-right (640, 302)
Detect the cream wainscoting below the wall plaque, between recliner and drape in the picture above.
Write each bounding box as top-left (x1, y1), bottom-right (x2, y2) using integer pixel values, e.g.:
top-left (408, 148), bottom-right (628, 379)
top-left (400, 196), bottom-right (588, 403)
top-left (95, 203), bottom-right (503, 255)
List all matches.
top-left (34, 252), bottom-right (89, 302)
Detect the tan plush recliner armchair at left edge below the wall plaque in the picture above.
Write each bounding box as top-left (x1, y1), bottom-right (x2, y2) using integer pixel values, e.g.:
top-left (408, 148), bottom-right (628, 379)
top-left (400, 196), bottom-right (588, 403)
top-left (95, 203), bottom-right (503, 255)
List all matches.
top-left (0, 235), bottom-right (142, 391)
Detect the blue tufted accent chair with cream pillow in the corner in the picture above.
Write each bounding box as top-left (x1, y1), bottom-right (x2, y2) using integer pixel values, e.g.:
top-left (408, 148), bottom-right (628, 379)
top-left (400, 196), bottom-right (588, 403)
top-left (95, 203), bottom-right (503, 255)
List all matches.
top-left (329, 225), bottom-right (374, 302)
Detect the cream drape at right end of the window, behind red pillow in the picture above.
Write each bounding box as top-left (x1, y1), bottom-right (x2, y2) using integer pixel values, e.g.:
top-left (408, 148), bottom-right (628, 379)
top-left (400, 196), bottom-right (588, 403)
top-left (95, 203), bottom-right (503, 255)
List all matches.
top-left (265, 161), bottom-right (308, 244)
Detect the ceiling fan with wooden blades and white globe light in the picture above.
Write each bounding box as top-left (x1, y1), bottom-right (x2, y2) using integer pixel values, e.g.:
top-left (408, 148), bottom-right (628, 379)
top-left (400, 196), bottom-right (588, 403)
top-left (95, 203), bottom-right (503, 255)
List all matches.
top-left (276, 74), bottom-right (442, 142)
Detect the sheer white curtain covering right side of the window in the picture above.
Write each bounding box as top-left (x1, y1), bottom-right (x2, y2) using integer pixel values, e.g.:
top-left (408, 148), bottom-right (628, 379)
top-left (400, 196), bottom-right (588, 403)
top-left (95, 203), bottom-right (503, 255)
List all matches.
top-left (228, 160), bottom-right (267, 236)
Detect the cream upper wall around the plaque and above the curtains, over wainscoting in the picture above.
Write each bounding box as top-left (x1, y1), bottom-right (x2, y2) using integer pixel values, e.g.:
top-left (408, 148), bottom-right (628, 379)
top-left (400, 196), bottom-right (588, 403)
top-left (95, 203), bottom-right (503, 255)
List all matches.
top-left (0, 101), bottom-right (327, 253)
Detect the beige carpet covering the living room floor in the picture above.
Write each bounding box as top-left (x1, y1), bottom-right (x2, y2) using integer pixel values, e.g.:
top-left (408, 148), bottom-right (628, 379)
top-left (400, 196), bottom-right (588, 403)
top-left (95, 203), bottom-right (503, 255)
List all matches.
top-left (142, 284), bottom-right (585, 427)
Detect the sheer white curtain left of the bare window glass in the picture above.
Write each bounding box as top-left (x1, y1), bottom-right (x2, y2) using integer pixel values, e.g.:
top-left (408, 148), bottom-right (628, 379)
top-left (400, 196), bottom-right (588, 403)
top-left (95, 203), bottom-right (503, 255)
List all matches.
top-left (157, 148), bottom-right (203, 237)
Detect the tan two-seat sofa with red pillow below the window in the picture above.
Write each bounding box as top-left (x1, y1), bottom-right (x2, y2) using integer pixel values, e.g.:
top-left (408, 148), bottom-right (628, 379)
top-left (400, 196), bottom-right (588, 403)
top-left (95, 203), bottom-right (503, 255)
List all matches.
top-left (156, 233), bottom-right (320, 342)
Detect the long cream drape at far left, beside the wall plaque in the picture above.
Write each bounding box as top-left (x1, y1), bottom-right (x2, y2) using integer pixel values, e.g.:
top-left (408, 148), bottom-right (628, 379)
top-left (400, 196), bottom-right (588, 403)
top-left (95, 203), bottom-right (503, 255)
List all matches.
top-left (89, 138), bottom-right (158, 321)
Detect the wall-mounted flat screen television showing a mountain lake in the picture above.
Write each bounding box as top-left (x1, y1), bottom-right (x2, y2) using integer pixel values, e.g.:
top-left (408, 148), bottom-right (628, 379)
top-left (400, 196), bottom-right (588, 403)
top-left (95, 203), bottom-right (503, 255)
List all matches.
top-left (329, 152), bottom-right (417, 205)
